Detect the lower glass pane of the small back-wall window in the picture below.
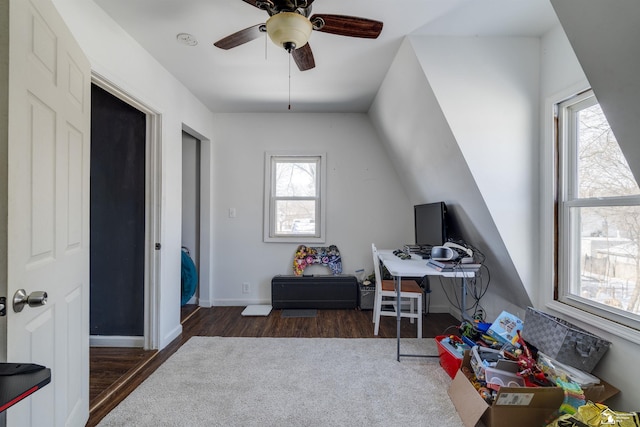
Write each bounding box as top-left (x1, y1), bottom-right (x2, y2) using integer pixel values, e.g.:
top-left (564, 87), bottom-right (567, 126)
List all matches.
top-left (275, 200), bottom-right (316, 236)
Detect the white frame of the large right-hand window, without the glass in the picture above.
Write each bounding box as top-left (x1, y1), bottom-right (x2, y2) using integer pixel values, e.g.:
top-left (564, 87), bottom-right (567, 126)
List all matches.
top-left (546, 89), bottom-right (640, 334)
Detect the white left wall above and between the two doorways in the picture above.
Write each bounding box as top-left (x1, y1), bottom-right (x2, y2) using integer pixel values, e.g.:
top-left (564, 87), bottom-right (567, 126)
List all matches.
top-left (54, 0), bottom-right (212, 348)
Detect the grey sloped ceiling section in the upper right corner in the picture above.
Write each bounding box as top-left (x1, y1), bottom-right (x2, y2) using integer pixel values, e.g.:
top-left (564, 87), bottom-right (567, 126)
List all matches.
top-left (551, 0), bottom-right (640, 181)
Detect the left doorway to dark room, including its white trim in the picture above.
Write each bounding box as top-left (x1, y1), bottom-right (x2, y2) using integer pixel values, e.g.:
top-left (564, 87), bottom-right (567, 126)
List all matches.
top-left (90, 75), bottom-right (160, 349)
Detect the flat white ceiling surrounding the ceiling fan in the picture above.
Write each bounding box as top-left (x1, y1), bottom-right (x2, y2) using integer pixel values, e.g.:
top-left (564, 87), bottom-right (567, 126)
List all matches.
top-left (94, 0), bottom-right (557, 112)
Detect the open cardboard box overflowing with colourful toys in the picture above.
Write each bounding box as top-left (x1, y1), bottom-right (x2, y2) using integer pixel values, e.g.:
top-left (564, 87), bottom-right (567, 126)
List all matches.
top-left (448, 313), bottom-right (619, 427)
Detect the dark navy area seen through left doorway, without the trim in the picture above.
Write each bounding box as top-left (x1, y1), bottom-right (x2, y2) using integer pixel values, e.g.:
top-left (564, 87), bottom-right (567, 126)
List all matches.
top-left (90, 85), bottom-right (146, 346)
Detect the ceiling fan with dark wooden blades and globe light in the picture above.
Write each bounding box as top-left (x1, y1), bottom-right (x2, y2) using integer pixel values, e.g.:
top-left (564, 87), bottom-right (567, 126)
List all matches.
top-left (213, 0), bottom-right (382, 71)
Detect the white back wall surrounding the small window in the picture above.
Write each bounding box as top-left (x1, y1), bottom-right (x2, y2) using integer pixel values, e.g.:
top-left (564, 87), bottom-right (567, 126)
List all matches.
top-left (208, 113), bottom-right (413, 305)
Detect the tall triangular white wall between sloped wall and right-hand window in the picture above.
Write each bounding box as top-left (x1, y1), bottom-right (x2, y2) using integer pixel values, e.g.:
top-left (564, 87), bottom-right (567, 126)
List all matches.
top-left (410, 37), bottom-right (540, 293)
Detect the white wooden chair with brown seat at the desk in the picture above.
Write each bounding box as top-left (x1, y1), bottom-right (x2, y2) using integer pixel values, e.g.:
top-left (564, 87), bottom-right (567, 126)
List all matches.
top-left (371, 243), bottom-right (422, 338)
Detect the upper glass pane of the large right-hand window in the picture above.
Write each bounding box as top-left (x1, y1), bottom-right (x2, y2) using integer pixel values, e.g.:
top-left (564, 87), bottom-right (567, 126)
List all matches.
top-left (576, 104), bottom-right (640, 198)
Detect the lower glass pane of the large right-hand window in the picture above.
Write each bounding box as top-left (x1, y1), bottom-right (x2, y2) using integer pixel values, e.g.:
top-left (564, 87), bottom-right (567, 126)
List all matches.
top-left (570, 206), bottom-right (640, 314)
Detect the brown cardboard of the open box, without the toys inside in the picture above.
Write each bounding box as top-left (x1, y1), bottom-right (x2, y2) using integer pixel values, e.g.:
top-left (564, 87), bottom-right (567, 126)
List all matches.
top-left (448, 352), bottom-right (619, 427)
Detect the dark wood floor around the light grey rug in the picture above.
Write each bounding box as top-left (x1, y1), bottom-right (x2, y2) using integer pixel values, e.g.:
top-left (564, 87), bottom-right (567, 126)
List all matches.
top-left (87, 306), bottom-right (458, 426)
